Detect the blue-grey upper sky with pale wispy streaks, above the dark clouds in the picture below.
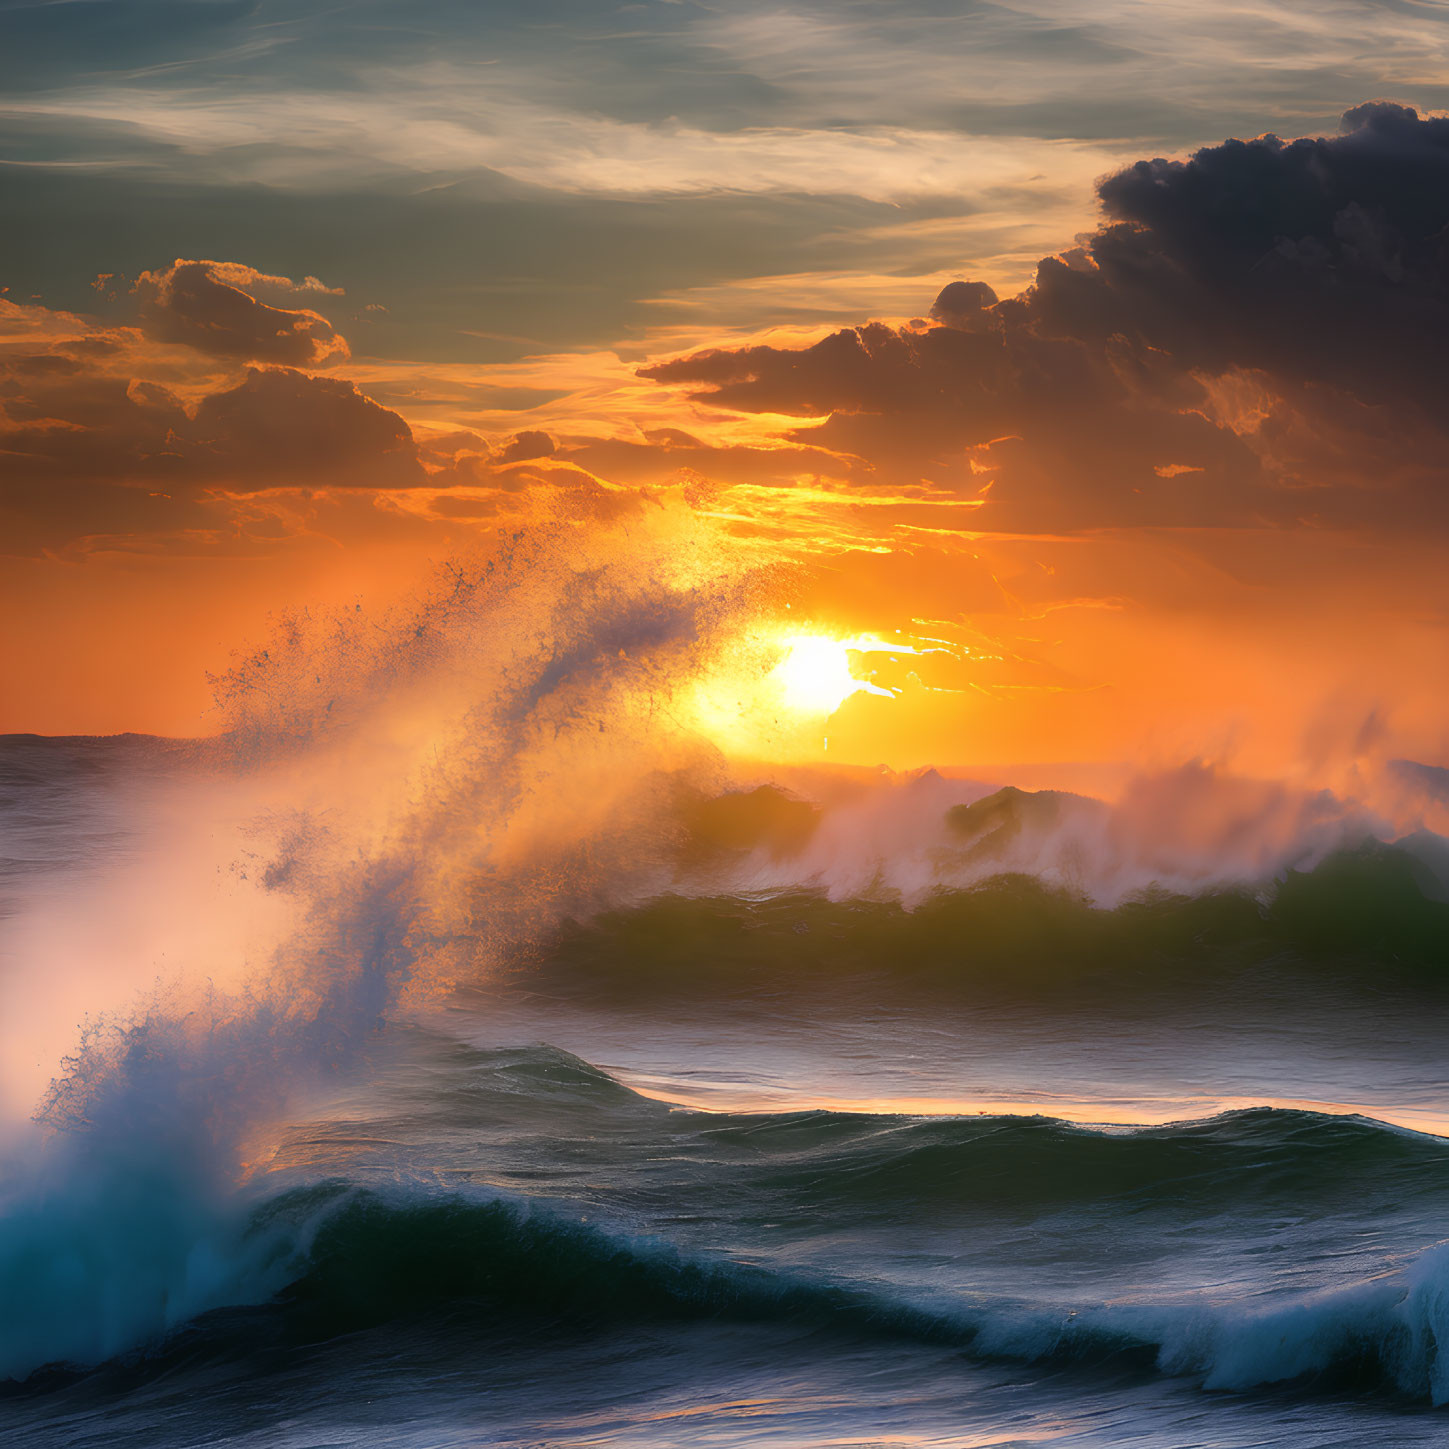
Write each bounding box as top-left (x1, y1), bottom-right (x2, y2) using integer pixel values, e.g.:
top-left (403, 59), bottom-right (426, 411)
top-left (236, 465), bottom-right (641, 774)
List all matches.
top-left (8, 0), bottom-right (1449, 362)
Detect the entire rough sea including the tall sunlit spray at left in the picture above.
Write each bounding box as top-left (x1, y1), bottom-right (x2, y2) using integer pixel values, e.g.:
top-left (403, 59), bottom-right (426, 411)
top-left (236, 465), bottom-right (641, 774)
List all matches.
top-left (0, 509), bottom-right (1449, 1443)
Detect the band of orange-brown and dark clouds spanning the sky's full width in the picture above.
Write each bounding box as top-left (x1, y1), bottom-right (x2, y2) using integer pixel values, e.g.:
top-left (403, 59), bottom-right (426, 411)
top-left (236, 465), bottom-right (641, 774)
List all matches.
top-left (8, 101), bottom-right (1449, 549)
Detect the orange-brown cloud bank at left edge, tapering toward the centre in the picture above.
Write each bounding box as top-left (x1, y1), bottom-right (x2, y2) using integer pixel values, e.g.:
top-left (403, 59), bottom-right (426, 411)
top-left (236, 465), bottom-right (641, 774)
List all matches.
top-left (0, 288), bottom-right (602, 556)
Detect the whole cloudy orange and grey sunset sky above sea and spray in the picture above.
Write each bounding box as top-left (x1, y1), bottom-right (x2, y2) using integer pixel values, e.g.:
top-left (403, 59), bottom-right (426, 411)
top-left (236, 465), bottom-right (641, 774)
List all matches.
top-left (0, 0), bottom-right (1449, 774)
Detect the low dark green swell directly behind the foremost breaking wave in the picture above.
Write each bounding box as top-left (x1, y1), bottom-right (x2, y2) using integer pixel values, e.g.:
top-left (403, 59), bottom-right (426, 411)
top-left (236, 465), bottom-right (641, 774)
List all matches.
top-left (320, 1043), bottom-right (1449, 1226)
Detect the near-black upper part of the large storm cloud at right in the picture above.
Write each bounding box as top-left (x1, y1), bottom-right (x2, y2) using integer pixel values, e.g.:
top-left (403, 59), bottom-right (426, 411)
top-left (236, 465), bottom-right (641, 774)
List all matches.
top-left (1029, 103), bottom-right (1449, 409)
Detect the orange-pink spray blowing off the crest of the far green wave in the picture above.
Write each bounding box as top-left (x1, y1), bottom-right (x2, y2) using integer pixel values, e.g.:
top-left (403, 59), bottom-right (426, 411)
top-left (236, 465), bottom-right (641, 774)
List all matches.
top-left (677, 762), bottom-right (1449, 907)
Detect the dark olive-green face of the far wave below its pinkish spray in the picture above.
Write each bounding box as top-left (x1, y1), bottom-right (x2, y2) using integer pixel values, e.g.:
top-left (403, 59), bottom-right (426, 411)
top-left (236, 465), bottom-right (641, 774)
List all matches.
top-left (527, 843), bottom-right (1449, 997)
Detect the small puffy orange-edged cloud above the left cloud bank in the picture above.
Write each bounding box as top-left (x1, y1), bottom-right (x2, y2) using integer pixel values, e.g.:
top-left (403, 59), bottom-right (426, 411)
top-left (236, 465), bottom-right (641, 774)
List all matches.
top-left (132, 258), bottom-right (348, 367)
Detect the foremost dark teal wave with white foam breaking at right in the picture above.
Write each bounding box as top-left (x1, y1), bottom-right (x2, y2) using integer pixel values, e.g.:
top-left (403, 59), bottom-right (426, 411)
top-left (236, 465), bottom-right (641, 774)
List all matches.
top-left (19, 1184), bottom-right (1449, 1404)
